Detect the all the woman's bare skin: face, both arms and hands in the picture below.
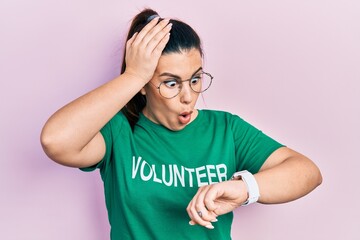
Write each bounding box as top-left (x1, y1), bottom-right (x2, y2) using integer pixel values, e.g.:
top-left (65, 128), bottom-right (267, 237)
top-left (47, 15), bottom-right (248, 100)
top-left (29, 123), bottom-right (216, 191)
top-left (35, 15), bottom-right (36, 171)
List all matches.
top-left (41, 18), bottom-right (322, 229)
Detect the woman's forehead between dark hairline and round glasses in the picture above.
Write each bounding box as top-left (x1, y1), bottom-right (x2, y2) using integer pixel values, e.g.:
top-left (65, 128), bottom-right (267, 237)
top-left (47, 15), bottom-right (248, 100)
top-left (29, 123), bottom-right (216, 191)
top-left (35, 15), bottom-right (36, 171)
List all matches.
top-left (155, 49), bottom-right (202, 77)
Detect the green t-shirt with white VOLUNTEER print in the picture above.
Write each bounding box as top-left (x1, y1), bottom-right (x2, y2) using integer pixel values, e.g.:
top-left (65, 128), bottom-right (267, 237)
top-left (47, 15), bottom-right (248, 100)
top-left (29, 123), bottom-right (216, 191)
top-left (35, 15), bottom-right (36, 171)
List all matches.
top-left (82, 110), bottom-right (282, 240)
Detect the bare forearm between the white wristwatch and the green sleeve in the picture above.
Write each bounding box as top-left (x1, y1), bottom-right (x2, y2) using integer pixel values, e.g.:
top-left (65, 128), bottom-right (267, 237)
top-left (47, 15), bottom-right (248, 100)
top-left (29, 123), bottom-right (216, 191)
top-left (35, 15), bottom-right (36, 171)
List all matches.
top-left (254, 147), bottom-right (322, 204)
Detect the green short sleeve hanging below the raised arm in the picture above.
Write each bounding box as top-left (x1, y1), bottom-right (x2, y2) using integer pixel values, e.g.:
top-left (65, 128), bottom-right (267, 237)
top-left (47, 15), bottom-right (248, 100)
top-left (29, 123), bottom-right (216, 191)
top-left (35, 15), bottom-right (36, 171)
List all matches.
top-left (80, 112), bottom-right (127, 172)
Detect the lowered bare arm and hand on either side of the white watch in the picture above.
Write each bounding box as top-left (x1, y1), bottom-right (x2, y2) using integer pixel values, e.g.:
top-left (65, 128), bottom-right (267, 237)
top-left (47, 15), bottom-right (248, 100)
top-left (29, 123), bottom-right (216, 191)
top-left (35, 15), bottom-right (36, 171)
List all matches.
top-left (187, 147), bottom-right (322, 228)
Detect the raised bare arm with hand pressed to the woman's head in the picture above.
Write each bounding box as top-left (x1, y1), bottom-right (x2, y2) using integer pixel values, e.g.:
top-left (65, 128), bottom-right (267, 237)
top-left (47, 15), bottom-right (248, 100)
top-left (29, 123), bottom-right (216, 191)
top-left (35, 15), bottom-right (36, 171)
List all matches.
top-left (41, 18), bottom-right (171, 167)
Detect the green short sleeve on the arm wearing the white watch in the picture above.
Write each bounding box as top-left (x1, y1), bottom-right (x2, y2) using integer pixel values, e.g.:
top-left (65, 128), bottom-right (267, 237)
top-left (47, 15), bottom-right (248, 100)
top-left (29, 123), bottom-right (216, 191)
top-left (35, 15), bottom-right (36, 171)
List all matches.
top-left (232, 115), bottom-right (284, 174)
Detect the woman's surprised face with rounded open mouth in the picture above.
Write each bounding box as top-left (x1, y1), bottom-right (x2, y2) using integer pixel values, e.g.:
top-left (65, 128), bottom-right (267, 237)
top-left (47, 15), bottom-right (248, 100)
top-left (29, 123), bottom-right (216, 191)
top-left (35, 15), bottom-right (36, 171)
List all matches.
top-left (141, 48), bottom-right (202, 131)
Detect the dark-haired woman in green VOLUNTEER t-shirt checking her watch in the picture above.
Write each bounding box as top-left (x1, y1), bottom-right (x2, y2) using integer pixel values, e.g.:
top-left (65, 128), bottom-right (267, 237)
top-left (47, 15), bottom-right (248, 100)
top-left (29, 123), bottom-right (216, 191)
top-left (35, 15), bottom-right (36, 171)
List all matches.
top-left (41, 9), bottom-right (322, 240)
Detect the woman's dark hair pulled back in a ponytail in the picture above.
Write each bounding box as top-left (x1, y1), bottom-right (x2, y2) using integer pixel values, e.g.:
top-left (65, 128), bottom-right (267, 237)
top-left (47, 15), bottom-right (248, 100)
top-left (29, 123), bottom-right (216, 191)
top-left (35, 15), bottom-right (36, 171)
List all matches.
top-left (121, 8), bottom-right (203, 128)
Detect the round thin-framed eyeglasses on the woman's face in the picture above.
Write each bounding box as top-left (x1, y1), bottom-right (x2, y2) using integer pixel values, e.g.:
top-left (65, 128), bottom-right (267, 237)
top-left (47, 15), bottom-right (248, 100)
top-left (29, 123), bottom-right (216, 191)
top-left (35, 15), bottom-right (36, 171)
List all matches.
top-left (149, 72), bottom-right (214, 99)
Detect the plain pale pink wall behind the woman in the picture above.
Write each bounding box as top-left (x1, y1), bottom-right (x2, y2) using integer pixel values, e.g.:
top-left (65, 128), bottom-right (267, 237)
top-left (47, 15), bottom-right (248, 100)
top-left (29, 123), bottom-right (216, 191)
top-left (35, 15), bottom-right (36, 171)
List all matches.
top-left (0, 0), bottom-right (360, 240)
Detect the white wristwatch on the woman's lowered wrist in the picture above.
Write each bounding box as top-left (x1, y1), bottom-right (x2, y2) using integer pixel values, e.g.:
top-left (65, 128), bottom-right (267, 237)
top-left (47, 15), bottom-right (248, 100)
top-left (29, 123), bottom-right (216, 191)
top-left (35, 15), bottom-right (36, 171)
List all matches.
top-left (231, 170), bottom-right (260, 206)
